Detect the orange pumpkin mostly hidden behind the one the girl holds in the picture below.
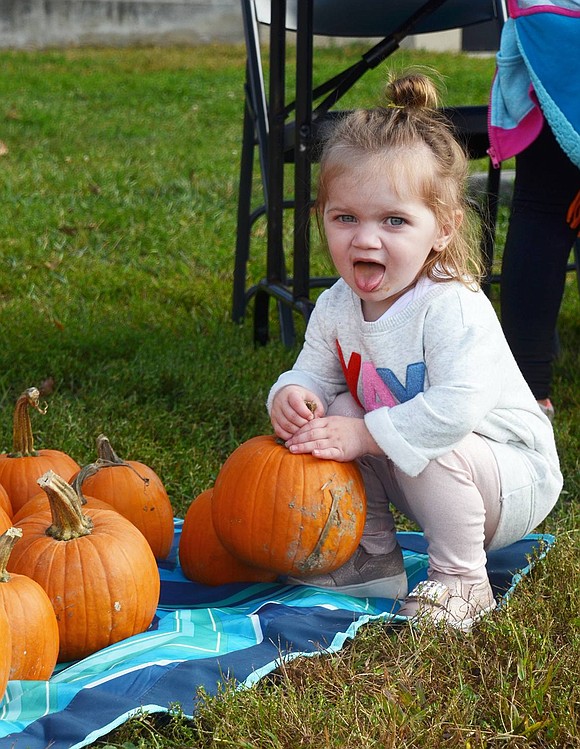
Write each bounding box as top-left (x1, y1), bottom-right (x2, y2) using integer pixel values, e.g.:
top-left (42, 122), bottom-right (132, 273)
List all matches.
top-left (179, 489), bottom-right (277, 585)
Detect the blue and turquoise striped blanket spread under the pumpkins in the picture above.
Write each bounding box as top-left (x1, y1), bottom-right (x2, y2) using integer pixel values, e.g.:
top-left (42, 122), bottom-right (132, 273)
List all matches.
top-left (0, 520), bottom-right (554, 749)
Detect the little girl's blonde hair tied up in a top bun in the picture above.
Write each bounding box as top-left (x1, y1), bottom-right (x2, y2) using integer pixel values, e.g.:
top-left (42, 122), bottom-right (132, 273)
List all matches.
top-left (314, 73), bottom-right (484, 288)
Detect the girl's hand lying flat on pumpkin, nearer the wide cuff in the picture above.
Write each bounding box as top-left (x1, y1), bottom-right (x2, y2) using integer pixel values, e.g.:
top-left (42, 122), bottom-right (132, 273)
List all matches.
top-left (286, 416), bottom-right (384, 463)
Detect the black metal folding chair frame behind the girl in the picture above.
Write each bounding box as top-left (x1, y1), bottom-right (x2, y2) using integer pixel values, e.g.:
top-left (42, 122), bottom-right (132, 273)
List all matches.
top-left (232, 0), bottom-right (506, 346)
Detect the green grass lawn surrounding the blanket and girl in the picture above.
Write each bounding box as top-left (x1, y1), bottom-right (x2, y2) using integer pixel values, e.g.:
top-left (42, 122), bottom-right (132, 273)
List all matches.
top-left (0, 46), bottom-right (580, 749)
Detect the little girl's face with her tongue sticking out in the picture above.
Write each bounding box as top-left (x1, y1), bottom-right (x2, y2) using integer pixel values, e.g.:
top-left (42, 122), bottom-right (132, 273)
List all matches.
top-left (323, 159), bottom-right (451, 321)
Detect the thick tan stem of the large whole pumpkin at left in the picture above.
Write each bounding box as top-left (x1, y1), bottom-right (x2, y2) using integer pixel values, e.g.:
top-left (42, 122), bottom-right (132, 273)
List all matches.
top-left (37, 471), bottom-right (93, 541)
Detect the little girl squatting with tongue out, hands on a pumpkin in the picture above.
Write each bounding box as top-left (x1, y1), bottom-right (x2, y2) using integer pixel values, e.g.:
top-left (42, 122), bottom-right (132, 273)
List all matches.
top-left (268, 74), bottom-right (562, 630)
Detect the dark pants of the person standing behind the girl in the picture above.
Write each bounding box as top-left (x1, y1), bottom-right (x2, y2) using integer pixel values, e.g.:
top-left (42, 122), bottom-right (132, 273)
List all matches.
top-left (501, 125), bottom-right (580, 400)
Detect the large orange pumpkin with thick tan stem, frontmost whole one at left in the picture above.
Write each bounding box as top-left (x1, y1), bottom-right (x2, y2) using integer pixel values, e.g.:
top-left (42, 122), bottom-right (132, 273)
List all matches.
top-left (8, 471), bottom-right (160, 662)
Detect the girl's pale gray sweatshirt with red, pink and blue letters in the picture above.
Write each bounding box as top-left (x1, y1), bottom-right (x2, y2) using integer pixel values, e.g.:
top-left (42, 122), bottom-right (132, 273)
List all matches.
top-left (268, 279), bottom-right (562, 547)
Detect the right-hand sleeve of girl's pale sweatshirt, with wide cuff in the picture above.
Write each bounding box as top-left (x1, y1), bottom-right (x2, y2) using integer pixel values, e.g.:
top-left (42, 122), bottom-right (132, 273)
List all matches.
top-left (365, 292), bottom-right (513, 476)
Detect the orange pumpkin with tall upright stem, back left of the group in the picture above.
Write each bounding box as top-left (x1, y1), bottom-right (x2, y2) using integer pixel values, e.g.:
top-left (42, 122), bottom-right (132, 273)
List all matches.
top-left (0, 387), bottom-right (80, 512)
